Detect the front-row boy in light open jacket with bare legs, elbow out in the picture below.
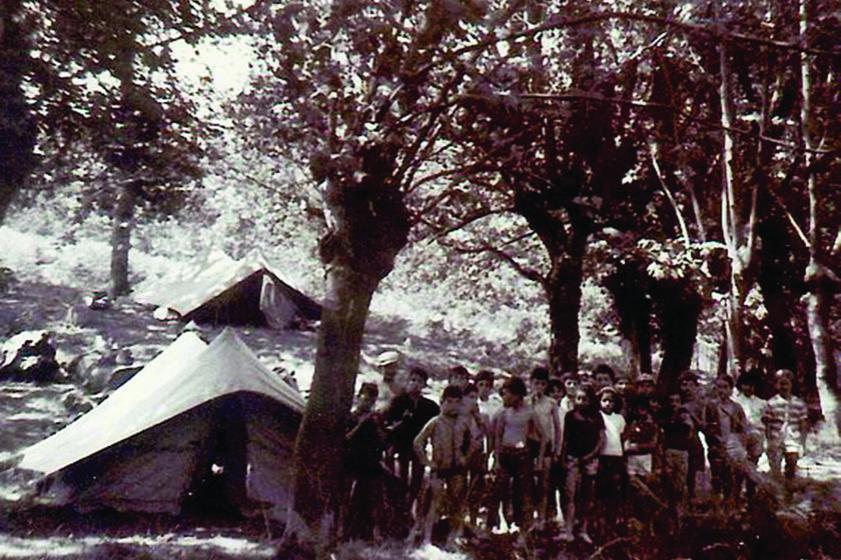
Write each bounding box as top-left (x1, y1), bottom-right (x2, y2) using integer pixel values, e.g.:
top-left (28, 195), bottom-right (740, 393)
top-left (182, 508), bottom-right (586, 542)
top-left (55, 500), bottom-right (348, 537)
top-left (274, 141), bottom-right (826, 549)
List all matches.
top-left (413, 385), bottom-right (474, 544)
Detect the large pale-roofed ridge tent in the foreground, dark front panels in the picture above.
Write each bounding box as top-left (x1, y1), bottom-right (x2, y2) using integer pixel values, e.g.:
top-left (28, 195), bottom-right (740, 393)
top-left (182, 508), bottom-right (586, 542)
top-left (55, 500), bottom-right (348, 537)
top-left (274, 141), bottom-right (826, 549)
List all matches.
top-left (17, 329), bottom-right (304, 514)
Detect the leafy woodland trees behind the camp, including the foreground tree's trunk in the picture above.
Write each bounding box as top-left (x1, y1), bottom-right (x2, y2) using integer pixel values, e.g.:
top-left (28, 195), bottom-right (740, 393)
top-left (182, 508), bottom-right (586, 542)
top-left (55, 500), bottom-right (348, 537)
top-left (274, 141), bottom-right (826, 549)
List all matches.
top-left (0, 0), bottom-right (841, 548)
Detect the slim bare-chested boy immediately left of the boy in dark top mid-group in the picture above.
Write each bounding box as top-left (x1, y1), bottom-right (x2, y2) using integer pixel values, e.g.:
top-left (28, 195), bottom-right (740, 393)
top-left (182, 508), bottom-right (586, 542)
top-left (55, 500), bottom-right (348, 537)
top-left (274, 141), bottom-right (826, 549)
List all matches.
top-left (526, 366), bottom-right (561, 527)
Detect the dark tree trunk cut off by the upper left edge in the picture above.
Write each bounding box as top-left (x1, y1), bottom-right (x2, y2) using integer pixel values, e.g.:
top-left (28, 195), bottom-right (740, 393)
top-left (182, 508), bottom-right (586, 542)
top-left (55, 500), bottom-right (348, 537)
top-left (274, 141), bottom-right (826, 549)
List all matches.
top-left (0, 0), bottom-right (37, 224)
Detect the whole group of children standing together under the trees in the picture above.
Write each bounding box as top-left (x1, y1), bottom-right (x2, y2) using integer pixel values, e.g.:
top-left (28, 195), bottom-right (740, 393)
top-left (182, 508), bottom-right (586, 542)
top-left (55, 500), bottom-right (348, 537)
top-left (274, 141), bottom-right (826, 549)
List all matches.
top-left (346, 353), bottom-right (807, 544)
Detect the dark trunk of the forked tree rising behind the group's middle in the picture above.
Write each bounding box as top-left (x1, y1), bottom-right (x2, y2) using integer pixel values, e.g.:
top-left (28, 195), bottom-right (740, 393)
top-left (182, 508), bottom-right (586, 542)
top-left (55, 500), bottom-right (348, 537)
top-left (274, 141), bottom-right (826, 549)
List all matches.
top-left (546, 235), bottom-right (586, 374)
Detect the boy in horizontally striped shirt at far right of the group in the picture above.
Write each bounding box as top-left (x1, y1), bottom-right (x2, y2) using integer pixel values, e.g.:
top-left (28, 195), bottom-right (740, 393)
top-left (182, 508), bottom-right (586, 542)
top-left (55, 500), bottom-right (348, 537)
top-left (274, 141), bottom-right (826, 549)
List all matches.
top-left (762, 369), bottom-right (808, 481)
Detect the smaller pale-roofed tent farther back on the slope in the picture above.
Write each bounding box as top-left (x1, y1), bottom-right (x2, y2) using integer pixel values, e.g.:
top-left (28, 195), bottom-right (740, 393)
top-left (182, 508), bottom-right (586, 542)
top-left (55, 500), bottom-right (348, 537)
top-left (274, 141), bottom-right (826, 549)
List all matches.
top-left (134, 252), bottom-right (321, 328)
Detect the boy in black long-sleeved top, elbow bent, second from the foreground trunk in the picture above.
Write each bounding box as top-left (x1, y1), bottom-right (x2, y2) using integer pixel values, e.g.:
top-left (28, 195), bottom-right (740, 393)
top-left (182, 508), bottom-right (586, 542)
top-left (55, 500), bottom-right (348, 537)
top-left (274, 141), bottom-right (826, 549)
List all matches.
top-left (384, 367), bottom-right (440, 507)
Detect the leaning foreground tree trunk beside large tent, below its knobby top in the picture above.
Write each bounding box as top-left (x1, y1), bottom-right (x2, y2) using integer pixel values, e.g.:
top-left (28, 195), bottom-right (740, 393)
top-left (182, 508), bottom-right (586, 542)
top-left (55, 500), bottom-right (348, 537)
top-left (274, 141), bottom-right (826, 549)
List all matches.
top-left (288, 266), bottom-right (379, 556)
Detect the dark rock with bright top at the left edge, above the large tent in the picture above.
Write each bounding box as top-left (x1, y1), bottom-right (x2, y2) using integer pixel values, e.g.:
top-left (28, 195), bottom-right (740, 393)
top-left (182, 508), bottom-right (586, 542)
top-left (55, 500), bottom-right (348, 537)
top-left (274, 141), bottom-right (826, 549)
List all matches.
top-left (0, 331), bottom-right (62, 383)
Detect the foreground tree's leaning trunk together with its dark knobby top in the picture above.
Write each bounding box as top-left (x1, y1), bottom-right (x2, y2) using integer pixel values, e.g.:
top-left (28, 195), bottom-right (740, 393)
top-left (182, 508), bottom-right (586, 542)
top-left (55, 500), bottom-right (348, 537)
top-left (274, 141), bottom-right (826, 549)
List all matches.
top-left (284, 164), bottom-right (411, 557)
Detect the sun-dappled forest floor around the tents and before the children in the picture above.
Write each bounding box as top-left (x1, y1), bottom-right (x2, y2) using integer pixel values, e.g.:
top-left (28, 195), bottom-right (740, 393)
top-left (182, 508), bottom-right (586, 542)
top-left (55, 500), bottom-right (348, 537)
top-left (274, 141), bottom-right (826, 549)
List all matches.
top-left (0, 230), bottom-right (841, 560)
